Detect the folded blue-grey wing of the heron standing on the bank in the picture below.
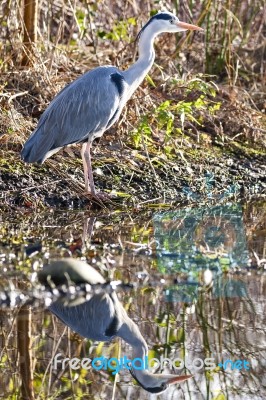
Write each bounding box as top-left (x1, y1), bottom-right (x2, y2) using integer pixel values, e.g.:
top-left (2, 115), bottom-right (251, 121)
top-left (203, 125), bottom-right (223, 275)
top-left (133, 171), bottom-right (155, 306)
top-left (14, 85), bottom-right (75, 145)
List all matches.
top-left (22, 67), bottom-right (123, 162)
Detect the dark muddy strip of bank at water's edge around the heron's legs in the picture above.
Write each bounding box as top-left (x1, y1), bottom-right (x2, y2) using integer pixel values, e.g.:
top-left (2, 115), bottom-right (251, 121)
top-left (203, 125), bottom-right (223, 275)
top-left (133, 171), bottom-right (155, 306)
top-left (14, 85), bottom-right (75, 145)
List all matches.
top-left (0, 141), bottom-right (266, 209)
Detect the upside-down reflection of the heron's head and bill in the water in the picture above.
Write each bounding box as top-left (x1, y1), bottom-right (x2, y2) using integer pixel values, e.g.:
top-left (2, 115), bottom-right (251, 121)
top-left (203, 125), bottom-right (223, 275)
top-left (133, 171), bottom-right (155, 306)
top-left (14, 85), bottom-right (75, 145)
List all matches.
top-left (130, 369), bottom-right (192, 394)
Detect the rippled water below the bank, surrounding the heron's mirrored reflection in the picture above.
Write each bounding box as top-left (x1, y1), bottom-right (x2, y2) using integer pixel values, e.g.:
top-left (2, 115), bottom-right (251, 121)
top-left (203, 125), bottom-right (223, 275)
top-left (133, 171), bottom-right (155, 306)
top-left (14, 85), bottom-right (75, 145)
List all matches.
top-left (0, 202), bottom-right (266, 400)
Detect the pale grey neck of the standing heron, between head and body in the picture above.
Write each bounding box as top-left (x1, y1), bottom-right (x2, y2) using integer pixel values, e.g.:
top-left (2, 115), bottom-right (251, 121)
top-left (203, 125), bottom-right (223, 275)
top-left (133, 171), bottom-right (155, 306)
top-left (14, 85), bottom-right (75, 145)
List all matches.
top-left (124, 27), bottom-right (158, 96)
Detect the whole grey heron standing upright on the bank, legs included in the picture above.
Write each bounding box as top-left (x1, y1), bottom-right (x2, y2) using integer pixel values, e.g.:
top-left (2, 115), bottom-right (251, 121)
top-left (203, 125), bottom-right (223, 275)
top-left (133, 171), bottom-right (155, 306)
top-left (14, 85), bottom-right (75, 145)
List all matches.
top-left (21, 11), bottom-right (203, 197)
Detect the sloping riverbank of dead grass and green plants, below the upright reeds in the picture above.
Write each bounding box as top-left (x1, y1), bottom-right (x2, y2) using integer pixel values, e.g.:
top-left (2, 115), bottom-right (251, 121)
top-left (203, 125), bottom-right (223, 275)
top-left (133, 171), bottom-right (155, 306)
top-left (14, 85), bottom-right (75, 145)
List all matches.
top-left (0, 66), bottom-right (266, 208)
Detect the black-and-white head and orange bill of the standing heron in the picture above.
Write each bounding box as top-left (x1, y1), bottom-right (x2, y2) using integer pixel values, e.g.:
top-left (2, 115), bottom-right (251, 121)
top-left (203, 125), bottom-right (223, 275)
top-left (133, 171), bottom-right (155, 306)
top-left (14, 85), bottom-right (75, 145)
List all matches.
top-left (137, 11), bottom-right (203, 39)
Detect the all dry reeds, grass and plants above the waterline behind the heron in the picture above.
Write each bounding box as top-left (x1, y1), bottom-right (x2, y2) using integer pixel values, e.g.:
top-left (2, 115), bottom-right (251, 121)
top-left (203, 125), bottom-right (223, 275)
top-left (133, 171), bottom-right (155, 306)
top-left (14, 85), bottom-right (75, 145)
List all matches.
top-left (0, 0), bottom-right (265, 207)
